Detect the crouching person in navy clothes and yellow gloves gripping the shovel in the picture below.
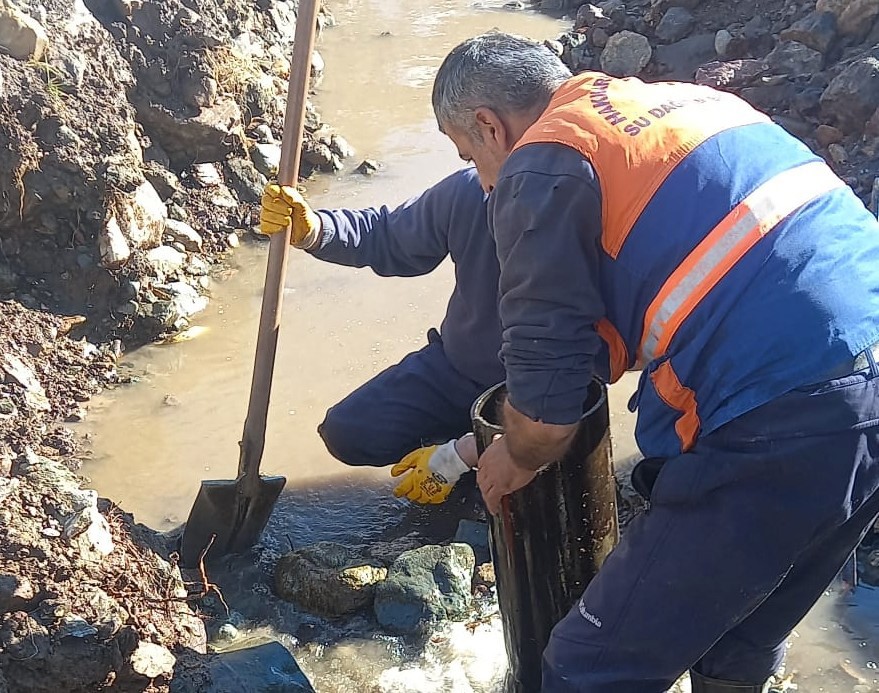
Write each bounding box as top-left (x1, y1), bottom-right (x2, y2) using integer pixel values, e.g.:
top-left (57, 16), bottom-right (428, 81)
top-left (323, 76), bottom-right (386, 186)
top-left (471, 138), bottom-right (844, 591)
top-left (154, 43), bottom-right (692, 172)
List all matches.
top-left (260, 167), bottom-right (503, 503)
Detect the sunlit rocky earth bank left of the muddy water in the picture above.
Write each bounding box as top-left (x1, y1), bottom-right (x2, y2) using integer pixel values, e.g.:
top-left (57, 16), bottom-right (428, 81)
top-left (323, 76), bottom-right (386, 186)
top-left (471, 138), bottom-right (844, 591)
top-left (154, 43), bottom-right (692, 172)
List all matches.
top-left (0, 0), bottom-right (360, 691)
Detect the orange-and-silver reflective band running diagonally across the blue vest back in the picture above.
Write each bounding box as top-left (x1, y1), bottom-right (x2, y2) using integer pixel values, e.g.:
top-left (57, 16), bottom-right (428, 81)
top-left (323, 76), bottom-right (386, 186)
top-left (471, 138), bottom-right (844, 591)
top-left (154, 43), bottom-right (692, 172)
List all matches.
top-left (639, 161), bottom-right (845, 364)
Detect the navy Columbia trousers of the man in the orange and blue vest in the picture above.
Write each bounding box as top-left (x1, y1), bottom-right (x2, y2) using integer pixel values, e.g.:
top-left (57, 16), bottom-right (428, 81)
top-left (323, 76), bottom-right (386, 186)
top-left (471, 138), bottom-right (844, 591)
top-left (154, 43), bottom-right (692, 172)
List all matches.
top-left (543, 364), bottom-right (879, 693)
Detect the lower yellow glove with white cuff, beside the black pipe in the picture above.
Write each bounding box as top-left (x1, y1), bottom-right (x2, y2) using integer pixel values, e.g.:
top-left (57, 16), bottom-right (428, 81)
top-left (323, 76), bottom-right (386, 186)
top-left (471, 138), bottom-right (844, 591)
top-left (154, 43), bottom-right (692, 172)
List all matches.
top-left (391, 440), bottom-right (470, 503)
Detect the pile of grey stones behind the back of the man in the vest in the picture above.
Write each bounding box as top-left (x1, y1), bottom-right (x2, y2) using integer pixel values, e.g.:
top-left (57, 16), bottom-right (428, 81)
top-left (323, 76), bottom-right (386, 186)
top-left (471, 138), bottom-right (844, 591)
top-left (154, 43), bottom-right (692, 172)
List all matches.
top-left (540, 0), bottom-right (879, 213)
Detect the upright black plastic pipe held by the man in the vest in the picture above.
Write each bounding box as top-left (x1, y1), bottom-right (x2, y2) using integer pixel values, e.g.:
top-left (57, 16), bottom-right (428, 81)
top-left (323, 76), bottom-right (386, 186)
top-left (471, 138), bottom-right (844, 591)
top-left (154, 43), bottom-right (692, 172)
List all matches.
top-left (472, 380), bottom-right (619, 693)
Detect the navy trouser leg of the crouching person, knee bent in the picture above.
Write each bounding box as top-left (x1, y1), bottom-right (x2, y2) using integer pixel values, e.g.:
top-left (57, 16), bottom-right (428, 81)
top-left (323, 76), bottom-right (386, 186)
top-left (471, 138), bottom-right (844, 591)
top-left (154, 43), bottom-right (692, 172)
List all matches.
top-left (317, 330), bottom-right (494, 467)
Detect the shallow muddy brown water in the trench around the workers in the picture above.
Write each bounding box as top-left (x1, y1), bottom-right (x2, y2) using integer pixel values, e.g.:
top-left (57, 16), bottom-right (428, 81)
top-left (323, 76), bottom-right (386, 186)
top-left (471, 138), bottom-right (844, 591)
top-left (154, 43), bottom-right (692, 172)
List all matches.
top-left (84, 0), bottom-right (879, 692)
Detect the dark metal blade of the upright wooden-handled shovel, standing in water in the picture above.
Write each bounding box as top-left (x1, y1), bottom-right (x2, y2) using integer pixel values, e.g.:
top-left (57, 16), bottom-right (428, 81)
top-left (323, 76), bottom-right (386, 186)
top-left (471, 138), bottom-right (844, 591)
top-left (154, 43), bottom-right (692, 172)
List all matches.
top-left (180, 476), bottom-right (287, 568)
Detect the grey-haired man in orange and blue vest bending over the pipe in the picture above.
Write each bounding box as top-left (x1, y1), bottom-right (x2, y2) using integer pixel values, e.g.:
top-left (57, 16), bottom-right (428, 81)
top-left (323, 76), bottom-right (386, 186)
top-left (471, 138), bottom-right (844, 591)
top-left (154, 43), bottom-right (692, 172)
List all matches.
top-left (433, 33), bottom-right (879, 693)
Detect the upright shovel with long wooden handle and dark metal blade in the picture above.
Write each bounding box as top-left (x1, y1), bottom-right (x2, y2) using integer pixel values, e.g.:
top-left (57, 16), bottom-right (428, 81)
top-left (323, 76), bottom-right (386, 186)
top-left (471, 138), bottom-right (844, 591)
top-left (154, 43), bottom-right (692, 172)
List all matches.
top-left (180, 0), bottom-right (320, 567)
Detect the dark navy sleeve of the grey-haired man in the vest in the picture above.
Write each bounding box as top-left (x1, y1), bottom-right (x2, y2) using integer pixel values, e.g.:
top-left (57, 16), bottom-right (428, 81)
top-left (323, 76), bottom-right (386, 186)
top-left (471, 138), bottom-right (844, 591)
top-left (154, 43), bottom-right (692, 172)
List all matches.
top-left (489, 144), bottom-right (605, 424)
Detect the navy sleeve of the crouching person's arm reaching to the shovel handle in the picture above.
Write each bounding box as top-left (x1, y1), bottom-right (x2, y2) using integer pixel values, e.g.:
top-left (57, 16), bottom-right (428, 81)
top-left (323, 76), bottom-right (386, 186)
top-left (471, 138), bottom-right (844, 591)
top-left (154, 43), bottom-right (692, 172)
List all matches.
top-left (312, 176), bottom-right (464, 277)
